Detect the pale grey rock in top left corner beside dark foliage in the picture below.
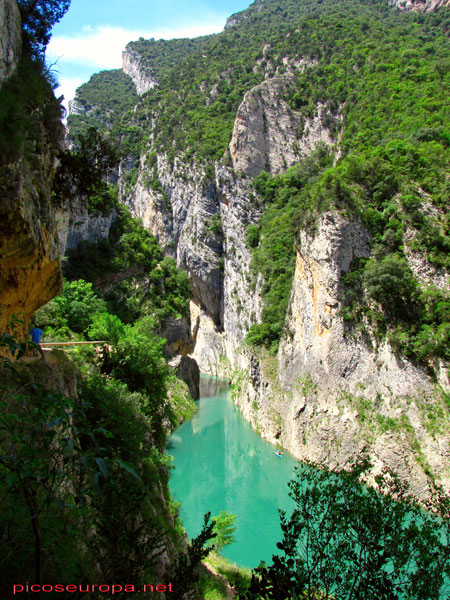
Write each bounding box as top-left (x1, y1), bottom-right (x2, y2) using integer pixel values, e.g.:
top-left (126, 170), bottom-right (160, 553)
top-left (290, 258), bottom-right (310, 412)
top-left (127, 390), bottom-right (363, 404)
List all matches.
top-left (0, 0), bottom-right (22, 86)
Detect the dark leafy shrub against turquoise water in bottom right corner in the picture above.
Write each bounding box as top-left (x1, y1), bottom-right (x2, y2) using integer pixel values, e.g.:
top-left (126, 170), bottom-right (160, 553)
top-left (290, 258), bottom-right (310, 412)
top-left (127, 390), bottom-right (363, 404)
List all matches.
top-left (240, 465), bottom-right (450, 600)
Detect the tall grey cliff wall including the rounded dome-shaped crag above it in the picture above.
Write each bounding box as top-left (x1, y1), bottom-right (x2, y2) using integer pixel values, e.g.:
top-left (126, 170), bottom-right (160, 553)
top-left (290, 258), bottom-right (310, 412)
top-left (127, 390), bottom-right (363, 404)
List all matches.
top-left (119, 71), bottom-right (334, 366)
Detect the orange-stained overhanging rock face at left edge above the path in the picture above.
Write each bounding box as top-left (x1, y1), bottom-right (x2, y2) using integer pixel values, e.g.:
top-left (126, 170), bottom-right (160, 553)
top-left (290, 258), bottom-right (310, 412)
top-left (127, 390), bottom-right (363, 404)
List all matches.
top-left (0, 152), bottom-right (62, 338)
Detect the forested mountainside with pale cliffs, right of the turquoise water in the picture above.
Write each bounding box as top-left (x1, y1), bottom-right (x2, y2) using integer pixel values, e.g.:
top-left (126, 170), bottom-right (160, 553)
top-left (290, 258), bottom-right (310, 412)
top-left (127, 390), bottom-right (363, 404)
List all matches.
top-left (69, 0), bottom-right (450, 495)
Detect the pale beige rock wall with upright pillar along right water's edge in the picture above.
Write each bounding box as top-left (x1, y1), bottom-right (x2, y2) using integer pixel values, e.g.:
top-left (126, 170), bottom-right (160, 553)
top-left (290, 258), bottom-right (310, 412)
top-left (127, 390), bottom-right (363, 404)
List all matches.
top-left (233, 213), bottom-right (450, 498)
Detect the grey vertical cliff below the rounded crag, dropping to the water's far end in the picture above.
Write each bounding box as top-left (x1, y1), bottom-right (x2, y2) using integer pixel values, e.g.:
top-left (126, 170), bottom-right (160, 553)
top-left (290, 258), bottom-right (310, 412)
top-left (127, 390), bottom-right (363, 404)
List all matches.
top-left (123, 151), bottom-right (260, 374)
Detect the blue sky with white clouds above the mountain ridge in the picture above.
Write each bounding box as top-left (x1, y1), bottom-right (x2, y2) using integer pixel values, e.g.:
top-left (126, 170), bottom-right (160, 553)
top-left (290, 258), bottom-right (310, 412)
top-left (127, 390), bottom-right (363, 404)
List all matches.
top-left (47, 0), bottom-right (252, 106)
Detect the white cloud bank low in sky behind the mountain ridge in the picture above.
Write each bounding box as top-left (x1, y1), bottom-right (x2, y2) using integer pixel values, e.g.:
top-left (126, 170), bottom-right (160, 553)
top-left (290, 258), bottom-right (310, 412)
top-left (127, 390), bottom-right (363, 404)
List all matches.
top-left (46, 22), bottom-right (223, 108)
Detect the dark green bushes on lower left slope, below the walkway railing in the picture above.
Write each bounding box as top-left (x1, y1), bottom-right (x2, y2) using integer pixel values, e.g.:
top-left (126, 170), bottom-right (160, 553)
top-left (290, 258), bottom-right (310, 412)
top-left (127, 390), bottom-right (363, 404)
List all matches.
top-left (0, 322), bottom-right (205, 598)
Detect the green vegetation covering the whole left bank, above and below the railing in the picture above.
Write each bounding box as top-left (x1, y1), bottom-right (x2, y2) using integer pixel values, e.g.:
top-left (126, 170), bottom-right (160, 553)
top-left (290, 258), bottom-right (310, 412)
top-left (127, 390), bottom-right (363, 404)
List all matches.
top-left (0, 188), bottom-right (199, 600)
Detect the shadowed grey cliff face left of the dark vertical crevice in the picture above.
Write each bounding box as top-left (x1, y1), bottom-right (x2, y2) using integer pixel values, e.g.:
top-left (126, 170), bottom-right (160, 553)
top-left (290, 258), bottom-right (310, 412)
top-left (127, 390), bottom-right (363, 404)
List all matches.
top-left (123, 156), bottom-right (223, 329)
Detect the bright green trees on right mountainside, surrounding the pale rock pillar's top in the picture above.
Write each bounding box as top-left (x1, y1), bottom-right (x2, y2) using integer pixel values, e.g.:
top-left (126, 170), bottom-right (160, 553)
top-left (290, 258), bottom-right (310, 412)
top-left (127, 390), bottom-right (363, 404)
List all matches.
top-left (236, 3), bottom-right (450, 356)
